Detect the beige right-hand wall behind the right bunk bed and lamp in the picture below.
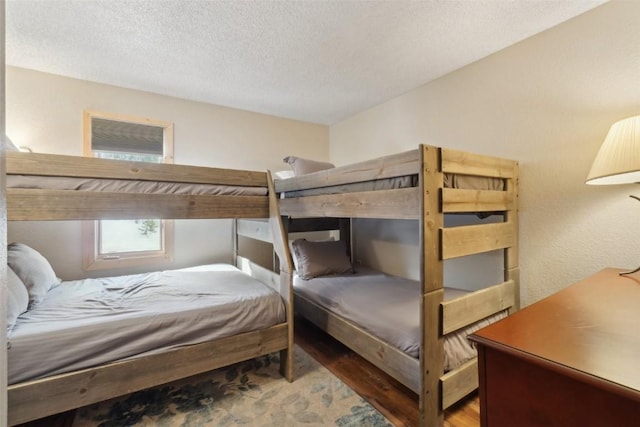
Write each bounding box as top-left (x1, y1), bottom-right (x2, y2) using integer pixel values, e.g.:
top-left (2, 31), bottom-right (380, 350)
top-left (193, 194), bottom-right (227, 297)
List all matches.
top-left (330, 1), bottom-right (640, 304)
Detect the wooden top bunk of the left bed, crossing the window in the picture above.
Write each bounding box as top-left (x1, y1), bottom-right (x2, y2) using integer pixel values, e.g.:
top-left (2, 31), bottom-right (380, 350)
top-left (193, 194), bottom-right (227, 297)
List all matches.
top-left (6, 152), bottom-right (269, 221)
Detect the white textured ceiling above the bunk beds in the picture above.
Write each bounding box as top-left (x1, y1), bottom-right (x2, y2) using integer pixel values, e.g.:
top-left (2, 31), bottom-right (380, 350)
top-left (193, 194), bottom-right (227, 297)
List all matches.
top-left (6, 0), bottom-right (605, 124)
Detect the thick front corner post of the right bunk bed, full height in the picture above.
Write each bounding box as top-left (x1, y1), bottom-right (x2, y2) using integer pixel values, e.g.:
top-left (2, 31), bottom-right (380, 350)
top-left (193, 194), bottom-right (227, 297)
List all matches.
top-left (419, 145), bottom-right (444, 427)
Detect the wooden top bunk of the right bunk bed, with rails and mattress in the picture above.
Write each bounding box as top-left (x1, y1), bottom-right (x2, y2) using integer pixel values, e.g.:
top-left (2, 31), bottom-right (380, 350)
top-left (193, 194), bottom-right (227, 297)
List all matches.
top-left (275, 145), bottom-right (518, 219)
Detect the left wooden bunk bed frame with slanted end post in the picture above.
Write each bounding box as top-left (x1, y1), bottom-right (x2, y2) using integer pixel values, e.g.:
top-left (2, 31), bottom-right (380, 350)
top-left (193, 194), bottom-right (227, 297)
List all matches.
top-left (6, 152), bottom-right (294, 425)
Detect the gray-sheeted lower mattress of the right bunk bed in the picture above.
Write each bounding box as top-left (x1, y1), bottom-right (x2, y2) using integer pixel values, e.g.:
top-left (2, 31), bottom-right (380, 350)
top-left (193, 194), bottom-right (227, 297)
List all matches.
top-left (293, 267), bottom-right (507, 371)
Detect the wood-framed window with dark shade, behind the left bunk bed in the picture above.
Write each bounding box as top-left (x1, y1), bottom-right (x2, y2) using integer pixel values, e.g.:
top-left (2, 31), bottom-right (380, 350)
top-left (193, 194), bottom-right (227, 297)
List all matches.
top-left (83, 111), bottom-right (178, 270)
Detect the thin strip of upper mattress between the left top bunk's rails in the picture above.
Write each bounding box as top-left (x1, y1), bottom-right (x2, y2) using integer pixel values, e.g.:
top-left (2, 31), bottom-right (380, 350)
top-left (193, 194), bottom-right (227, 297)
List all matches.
top-left (7, 175), bottom-right (267, 196)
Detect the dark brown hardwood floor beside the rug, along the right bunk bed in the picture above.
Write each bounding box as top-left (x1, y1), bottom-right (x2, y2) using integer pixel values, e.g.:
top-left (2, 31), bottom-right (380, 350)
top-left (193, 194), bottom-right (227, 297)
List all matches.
top-left (19, 318), bottom-right (480, 427)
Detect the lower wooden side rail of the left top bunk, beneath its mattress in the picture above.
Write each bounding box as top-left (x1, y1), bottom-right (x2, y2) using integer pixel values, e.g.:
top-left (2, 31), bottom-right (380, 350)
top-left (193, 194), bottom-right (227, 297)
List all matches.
top-left (7, 188), bottom-right (269, 221)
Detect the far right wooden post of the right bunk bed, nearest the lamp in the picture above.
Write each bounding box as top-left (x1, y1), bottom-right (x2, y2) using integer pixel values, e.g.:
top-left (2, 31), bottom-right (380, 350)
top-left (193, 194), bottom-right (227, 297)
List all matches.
top-left (504, 163), bottom-right (520, 313)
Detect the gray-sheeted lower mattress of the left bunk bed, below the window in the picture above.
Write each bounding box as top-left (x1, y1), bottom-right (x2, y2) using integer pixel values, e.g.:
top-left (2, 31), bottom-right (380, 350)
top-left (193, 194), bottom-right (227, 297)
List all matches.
top-left (7, 264), bottom-right (285, 384)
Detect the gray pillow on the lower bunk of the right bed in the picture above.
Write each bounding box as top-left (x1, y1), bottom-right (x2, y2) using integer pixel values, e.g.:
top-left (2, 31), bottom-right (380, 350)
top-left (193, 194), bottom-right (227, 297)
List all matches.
top-left (291, 239), bottom-right (353, 280)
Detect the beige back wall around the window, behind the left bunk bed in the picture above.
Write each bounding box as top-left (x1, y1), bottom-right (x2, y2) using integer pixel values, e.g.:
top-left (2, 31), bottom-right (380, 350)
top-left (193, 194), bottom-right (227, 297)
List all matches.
top-left (7, 67), bottom-right (328, 279)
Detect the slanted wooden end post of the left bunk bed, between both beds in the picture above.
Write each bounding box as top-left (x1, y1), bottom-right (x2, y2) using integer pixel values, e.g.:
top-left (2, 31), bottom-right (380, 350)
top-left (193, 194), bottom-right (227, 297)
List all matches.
top-left (267, 171), bottom-right (295, 381)
